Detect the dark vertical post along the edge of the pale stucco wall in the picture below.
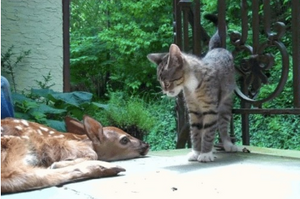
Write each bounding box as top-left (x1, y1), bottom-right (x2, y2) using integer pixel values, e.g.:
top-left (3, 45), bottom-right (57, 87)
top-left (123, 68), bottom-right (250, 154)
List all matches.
top-left (62, 0), bottom-right (71, 92)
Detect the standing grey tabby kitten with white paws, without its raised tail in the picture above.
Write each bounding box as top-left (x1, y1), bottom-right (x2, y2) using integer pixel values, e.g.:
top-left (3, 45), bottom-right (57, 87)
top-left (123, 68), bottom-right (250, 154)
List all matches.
top-left (147, 40), bottom-right (237, 162)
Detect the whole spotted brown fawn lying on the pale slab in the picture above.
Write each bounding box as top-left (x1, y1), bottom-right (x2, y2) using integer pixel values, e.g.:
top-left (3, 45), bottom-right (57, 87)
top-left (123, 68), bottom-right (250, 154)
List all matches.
top-left (1, 116), bottom-right (149, 193)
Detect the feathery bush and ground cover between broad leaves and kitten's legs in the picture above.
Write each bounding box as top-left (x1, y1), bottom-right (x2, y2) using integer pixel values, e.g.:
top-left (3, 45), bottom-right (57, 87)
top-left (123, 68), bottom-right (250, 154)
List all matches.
top-left (95, 92), bottom-right (176, 151)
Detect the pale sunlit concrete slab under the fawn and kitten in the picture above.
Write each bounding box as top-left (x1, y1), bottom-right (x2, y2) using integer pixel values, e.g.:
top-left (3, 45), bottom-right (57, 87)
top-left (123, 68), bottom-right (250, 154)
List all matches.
top-left (1, 147), bottom-right (300, 199)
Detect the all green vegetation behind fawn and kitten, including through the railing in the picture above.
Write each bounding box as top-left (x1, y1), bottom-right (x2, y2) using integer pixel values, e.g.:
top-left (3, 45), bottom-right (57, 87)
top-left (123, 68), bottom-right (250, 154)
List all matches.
top-left (4, 0), bottom-right (300, 150)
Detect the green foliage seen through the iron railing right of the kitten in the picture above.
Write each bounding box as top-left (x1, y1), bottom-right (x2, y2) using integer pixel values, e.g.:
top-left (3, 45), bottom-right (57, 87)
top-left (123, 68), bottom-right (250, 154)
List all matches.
top-left (226, 0), bottom-right (300, 150)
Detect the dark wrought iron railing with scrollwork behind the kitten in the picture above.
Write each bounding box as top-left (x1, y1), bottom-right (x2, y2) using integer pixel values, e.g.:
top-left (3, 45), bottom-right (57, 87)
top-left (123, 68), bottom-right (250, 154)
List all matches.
top-left (173, 0), bottom-right (300, 148)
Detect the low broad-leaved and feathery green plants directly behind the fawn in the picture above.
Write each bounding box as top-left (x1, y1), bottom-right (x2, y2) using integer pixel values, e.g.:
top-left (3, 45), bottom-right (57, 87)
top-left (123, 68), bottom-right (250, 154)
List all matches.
top-left (12, 89), bottom-right (176, 150)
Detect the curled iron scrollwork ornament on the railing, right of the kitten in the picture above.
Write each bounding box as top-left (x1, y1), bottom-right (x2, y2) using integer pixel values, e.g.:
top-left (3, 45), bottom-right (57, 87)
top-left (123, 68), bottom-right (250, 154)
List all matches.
top-left (230, 0), bottom-right (289, 107)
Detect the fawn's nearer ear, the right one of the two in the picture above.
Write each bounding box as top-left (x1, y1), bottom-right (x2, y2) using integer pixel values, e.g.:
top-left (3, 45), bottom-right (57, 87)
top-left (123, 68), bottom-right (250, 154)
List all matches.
top-left (83, 115), bottom-right (105, 144)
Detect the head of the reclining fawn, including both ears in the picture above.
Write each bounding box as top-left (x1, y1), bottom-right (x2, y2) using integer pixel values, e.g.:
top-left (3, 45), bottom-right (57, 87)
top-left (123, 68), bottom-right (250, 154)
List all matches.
top-left (66, 116), bottom-right (149, 161)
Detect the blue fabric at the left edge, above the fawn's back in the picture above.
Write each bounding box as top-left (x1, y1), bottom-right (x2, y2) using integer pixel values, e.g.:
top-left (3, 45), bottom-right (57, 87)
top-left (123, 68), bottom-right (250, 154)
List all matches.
top-left (1, 76), bottom-right (14, 119)
